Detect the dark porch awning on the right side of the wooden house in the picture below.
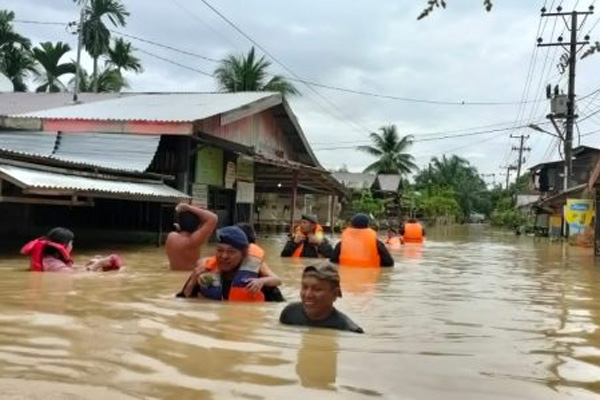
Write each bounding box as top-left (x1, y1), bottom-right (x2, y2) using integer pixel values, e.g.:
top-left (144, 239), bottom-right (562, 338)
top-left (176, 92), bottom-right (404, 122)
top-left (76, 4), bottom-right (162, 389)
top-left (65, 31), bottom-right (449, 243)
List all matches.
top-left (254, 154), bottom-right (346, 196)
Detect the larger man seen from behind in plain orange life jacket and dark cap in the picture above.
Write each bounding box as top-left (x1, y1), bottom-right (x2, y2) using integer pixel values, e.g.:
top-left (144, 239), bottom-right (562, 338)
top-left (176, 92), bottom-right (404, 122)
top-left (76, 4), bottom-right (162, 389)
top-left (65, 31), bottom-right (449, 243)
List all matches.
top-left (331, 214), bottom-right (394, 267)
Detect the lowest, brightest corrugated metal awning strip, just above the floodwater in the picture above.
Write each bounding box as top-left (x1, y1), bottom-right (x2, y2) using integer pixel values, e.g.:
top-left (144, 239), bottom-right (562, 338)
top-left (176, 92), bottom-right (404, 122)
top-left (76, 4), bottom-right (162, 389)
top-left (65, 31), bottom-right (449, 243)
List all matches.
top-left (0, 164), bottom-right (189, 202)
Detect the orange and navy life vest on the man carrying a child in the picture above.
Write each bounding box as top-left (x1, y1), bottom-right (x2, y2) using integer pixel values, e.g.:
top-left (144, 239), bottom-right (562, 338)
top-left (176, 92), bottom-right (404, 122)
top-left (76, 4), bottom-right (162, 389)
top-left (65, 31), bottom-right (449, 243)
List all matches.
top-left (198, 243), bottom-right (265, 302)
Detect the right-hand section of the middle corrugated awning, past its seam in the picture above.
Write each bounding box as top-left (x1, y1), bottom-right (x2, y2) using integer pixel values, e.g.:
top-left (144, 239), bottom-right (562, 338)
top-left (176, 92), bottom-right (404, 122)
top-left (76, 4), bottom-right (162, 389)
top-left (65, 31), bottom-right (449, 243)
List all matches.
top-left (52, 132), bottom-right (160, 172)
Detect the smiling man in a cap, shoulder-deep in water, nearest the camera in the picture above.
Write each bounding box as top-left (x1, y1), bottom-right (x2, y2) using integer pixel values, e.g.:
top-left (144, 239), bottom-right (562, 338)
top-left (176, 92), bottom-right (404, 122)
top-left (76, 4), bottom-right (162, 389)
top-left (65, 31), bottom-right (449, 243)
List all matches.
top-left (279, 261), bottom-right (364, 333)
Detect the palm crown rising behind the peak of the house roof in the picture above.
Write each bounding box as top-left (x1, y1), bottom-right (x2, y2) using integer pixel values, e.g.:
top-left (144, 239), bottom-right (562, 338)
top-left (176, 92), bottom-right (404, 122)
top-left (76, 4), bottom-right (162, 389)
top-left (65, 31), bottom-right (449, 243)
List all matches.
top-left (214, 47), bottom-right (300, 95)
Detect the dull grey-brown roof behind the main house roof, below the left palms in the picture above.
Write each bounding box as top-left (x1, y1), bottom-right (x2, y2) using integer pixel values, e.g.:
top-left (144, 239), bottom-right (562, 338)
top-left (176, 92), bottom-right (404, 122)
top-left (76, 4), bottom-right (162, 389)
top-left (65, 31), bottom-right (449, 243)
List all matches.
top-left (0, 92), bottom-right (133, 115)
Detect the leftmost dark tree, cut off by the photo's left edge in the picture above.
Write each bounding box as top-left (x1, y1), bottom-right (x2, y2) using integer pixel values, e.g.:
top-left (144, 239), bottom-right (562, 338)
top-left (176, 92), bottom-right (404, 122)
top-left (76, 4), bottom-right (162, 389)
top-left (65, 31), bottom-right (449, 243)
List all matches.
top-left (0, 10), bottom-right (35, 92)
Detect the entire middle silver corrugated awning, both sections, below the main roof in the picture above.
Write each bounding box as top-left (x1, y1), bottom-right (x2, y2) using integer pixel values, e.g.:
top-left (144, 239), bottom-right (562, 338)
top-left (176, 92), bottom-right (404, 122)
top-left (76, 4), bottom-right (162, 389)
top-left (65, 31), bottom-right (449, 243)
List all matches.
top-left (0, 131), bottom-right (160, 173)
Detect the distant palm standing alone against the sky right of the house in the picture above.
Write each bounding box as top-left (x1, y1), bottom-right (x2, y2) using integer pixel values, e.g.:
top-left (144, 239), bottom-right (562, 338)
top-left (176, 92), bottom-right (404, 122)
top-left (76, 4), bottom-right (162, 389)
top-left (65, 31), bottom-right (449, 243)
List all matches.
top-left (357, 125), bottom-right (417, 175)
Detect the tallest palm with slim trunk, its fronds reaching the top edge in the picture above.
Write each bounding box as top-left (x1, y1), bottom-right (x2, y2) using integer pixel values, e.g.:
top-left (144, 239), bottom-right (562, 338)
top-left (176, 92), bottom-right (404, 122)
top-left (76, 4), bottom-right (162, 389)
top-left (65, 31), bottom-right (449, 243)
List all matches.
top-left (83, 0), bottom-right (129, 92)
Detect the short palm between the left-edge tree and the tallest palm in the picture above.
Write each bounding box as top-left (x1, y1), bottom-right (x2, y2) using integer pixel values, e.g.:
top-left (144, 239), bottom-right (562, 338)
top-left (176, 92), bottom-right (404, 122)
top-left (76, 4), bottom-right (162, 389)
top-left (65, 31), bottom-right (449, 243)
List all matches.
top-left (32, 42), bottom-right (75, 92)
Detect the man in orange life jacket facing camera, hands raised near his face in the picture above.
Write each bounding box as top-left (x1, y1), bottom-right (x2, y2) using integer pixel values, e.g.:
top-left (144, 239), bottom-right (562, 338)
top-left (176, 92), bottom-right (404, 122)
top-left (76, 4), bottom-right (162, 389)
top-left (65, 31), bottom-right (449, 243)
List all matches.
top-left (281, 214), bottom-right (333, 258)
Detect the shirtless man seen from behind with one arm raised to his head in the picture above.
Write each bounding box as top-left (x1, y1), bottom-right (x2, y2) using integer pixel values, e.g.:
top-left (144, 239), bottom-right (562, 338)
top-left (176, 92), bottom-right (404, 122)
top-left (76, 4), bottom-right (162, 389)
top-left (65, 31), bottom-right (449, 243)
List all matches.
top-left (165, 203), bottom-right (217, 271)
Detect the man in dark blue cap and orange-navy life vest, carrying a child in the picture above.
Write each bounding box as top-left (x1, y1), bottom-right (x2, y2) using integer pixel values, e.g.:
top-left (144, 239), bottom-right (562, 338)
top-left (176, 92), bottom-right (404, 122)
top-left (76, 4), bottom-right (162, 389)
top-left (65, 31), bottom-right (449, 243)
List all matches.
top-left (177, 226), bottom-right (285, 302)
